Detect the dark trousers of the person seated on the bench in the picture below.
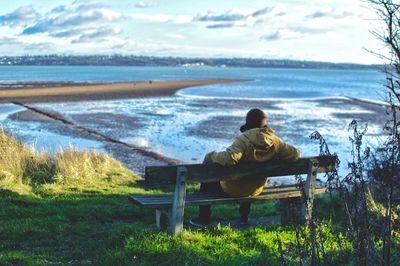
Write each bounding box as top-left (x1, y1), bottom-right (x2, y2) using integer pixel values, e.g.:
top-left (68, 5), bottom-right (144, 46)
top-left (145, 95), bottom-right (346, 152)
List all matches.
top-left (199, 182), bottom-right (251, 222)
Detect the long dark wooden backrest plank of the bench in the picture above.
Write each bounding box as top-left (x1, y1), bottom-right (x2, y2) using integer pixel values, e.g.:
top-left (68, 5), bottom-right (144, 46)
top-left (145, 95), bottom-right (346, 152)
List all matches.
top-left (145, 156), bottom-right (336, 187)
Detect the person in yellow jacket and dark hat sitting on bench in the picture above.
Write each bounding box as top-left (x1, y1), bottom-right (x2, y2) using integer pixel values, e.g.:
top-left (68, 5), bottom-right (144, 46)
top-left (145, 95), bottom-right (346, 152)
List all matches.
top-left (190, 109), bottom-right (300, 226)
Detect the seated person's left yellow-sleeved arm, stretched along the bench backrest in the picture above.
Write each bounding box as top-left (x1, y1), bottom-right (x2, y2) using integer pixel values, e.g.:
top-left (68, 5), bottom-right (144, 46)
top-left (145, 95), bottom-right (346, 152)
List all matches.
top-left (203, 139), bottom-right (245, 166)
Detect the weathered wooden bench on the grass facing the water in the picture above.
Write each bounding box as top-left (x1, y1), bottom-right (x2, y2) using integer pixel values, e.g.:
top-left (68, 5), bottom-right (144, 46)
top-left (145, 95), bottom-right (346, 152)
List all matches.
top-left (128, 156), bottom-right (336, 235)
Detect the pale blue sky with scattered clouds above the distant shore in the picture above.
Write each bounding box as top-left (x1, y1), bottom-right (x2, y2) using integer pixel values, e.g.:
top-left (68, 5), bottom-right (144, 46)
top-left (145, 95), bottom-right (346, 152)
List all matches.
top-left (0, 0), bottom-right (381, 63)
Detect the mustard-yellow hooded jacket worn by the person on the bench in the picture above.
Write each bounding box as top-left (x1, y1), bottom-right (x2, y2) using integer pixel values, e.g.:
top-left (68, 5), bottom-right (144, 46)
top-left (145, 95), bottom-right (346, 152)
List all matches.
top-left (203, 127), bottom-right (300, 197)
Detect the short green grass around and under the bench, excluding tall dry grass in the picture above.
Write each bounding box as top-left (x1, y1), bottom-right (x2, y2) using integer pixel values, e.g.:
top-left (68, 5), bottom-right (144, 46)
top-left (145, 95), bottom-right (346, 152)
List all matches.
top-left (0, 184), bottom-right (350, 265)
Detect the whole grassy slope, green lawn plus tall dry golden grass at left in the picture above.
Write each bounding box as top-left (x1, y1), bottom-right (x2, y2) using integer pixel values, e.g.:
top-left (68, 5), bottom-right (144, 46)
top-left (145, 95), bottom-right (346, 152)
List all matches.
top-left (0, 132), bottom-right (390, 265)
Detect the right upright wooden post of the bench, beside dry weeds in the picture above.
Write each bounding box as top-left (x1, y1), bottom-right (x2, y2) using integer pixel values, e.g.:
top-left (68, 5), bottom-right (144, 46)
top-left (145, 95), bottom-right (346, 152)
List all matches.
top-left (303, 159), bottom-right (319, 223)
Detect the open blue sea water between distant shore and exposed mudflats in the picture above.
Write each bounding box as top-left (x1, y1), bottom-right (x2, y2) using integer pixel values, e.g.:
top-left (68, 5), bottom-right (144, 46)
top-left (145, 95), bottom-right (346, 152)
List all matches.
top-left (0, 66), bottom-right (385, 101)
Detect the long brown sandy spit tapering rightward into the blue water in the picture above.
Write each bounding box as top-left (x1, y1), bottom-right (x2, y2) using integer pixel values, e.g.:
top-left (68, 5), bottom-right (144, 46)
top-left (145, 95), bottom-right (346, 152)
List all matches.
top-left (0, 79), bottom-right (250, 103)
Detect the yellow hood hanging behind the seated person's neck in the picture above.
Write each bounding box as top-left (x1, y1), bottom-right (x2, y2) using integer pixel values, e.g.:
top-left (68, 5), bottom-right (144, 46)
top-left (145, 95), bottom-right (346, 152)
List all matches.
top-left (240, 127), bottom-right (275, 150)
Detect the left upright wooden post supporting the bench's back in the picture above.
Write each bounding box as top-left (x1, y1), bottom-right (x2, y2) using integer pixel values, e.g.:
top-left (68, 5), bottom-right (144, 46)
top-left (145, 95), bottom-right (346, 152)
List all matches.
top-left (170, 166), bottom-right (187, 235)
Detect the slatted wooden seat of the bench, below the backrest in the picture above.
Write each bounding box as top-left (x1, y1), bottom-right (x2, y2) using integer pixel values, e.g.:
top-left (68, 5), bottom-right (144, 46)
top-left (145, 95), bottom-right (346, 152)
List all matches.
top-left (128, 187), bottom-right (326, 208)
